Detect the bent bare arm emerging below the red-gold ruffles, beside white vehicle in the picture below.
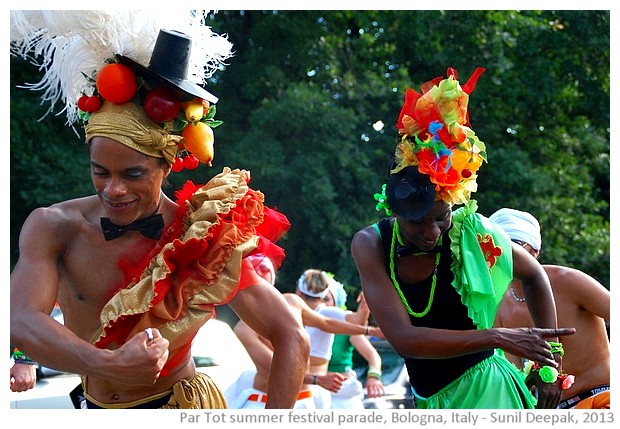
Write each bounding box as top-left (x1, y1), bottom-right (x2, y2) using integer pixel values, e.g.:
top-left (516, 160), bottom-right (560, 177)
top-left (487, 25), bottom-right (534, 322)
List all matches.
top-left (230, 279), bottom-right (310, 409)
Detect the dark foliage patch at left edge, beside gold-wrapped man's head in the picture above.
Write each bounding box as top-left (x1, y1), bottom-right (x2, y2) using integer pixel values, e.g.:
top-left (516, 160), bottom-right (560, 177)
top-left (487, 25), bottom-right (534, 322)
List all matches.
top-left (10, 59), bottom-right (92, 267)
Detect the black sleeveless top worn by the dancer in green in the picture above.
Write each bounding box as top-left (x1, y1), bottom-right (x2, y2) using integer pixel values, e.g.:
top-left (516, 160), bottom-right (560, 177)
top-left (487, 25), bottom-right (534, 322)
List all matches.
top-left (377, 218), bottom-right (493, 397)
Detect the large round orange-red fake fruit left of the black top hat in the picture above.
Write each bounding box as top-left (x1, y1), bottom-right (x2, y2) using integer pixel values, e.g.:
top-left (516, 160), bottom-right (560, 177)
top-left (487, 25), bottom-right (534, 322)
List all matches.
top-left (96, 63), bottom-right (138, 104)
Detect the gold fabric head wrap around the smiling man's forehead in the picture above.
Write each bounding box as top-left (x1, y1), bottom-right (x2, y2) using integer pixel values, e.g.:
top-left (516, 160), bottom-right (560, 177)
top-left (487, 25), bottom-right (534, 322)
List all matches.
top-left (85, 101), bottom-right (183, 166)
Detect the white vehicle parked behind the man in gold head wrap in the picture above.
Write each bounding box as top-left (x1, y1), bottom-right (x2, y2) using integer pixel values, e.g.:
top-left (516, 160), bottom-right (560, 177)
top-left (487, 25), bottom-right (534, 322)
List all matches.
top-left (9, 315), bottom-right (256, 409)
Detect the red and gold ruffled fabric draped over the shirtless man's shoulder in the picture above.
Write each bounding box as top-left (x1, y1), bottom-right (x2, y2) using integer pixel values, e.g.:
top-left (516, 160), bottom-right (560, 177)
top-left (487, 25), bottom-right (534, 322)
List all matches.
top-left (93, 170), bottom-right (290, 375)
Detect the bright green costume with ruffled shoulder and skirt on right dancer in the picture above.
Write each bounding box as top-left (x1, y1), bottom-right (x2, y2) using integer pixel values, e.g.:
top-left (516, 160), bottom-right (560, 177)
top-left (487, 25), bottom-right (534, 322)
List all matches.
top-left (382, 200), bottom-right (536, 409)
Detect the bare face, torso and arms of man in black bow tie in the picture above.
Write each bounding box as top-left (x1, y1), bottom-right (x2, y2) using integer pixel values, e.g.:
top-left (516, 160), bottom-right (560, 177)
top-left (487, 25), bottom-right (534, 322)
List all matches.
top-left (11, 134), bottom-right (307, 408)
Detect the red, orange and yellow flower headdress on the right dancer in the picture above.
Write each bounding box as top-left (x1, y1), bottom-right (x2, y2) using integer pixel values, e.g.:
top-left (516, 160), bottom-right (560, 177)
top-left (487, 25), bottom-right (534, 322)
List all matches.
top-left (392, 67), bottom-right (486, 204)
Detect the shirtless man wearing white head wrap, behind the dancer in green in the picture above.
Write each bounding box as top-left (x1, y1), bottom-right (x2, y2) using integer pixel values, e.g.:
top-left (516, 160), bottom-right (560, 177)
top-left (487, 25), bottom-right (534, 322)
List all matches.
top-left (490, 208), bottom-right (610, 408)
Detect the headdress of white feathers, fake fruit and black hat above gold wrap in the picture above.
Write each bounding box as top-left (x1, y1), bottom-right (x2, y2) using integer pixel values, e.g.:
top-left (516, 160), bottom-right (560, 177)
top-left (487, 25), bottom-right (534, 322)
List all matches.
top-left (11, 9), bottom-right (232, 171)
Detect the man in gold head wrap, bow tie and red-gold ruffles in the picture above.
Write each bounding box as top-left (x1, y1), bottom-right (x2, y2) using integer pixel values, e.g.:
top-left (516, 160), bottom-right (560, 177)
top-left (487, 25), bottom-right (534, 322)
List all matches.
top-left (10, 11), bottom-right (308, 408)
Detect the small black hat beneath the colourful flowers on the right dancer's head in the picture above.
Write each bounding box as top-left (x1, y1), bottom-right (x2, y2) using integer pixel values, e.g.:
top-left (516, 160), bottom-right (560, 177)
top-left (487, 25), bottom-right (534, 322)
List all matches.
top-left (385, 162), bottom-right (436, 220)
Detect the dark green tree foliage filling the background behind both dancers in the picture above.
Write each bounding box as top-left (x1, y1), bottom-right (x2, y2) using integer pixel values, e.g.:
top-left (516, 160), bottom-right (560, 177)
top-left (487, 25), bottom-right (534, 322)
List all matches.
top-left (11, 10), bottom-right (610, 297)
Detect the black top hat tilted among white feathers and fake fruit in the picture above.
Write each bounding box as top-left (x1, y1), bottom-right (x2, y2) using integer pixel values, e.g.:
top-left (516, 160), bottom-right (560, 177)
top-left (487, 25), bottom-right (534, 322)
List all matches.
top-left (117, 29), bottom-right (218, 104)
